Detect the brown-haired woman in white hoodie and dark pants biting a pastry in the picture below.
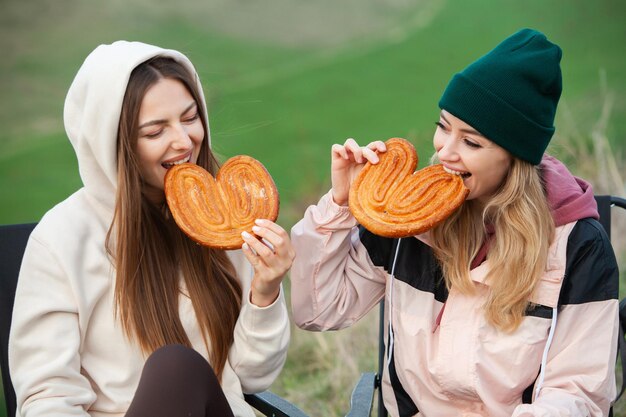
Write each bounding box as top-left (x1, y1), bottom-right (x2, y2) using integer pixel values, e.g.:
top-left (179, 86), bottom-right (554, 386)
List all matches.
top-left (9, 41), bottom-right (294, 417)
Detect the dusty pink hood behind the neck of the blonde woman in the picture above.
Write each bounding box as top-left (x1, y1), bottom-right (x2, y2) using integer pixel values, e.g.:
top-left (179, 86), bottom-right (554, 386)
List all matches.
top-left (540, 155), bottom-right (600, 227)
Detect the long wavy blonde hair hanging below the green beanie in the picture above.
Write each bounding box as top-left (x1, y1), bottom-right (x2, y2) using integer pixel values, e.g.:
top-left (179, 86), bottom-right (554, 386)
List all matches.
top-left (431, 158), bottom-right (554, 331)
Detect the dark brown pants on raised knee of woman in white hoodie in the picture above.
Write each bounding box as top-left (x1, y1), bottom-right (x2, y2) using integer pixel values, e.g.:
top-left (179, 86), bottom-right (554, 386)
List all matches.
top-left (126, 345), bottom-right (233, 417)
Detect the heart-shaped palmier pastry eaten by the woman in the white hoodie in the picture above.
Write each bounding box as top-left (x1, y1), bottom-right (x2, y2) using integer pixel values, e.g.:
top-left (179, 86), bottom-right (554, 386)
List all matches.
top-left (165, 155), bottom-right (279, 249)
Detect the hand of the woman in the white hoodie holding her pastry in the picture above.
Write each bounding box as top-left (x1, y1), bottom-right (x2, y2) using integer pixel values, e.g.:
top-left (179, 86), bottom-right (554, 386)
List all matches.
top-left (241, 219), bottom-right (296, 307)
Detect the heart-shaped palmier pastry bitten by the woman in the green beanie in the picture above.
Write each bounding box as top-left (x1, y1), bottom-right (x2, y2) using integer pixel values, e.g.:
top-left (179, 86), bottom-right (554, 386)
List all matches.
top-left (349, 138), bottom-right (469, 238)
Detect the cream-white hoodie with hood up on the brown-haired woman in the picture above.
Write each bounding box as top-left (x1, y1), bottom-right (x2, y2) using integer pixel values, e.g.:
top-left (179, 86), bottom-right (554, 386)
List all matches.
top-left (9, 41), bottom-right (289, 417)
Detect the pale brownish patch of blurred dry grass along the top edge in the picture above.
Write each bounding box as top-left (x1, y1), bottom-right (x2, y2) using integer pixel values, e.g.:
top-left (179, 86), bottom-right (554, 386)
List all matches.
top-left (113, 0), bottom-right (441, 48)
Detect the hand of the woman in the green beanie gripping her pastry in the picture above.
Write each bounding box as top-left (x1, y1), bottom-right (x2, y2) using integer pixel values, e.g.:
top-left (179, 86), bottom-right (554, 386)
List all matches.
top-left (331, 138), bottom-right (386, 206)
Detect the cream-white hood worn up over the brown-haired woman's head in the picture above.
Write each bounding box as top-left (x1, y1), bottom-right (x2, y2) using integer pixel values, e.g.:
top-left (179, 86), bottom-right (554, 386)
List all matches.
top-left (63, 41), bottom-right (210, 210)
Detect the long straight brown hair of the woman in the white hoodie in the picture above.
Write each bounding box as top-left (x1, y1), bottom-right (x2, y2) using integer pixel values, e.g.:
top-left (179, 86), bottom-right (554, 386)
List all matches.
top-left (106, 57), bottom-right (241, 379)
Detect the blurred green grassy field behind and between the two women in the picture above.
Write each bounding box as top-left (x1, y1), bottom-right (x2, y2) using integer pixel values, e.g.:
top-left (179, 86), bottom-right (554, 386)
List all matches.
top-left (0, 0), bottom-right (626, 416)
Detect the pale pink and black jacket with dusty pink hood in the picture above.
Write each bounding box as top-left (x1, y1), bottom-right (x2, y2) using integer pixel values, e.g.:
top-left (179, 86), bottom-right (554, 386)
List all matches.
top-left (291, 157), bottom-right (618, 417)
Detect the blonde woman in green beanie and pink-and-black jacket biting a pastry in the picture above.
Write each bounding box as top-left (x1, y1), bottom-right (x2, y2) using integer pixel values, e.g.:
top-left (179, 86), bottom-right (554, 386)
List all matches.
top-left (291, 29), bottom-right (618, 417)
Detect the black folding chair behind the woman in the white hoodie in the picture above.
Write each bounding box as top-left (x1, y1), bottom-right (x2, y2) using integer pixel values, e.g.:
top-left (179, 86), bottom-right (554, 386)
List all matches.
top-left (0, 223), bottom-right (308, 417)
